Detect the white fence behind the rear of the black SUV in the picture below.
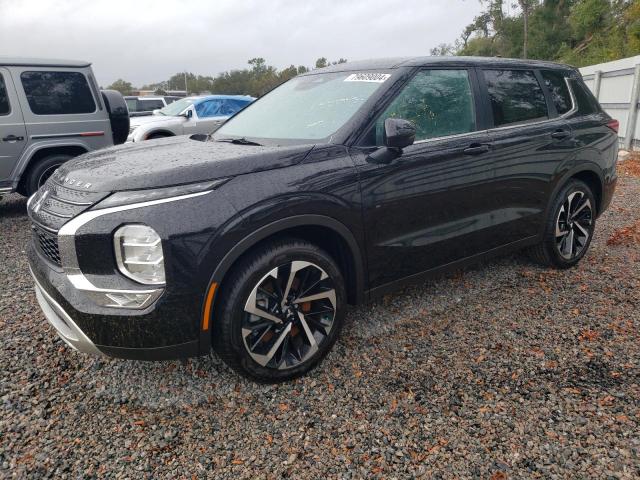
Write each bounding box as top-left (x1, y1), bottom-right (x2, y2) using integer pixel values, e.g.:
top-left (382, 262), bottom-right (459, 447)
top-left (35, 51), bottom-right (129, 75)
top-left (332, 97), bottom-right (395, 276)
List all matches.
top-left (580, 55), bottom-right (640, 150)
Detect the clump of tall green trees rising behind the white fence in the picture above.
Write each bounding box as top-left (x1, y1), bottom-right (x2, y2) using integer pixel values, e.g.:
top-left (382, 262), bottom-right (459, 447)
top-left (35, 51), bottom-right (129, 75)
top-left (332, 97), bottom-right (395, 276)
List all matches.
top-left (457, 0), bottom-right (640, 66)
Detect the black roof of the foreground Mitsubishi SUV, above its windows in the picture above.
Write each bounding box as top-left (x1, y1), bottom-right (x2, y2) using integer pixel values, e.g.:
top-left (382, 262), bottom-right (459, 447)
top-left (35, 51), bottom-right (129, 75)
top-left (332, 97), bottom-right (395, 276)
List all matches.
top-left (305, 57), bottom-right (574, 75)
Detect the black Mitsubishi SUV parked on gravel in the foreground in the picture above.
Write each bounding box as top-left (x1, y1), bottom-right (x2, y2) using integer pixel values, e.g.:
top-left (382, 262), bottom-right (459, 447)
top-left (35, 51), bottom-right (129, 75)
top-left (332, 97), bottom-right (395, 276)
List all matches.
top-left (28, 57), bottom-right (618, 381)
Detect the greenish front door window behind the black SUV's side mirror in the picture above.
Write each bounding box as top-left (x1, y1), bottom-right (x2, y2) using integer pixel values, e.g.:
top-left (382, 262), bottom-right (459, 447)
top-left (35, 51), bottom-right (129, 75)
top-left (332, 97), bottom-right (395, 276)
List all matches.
top-left (375, 70), bottom-right (476, 145)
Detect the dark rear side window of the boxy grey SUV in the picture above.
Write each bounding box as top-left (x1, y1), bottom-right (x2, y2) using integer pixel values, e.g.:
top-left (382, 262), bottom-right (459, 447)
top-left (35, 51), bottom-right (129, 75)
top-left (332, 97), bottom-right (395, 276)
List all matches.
top-left (20, 72), bottom-right (96, 115)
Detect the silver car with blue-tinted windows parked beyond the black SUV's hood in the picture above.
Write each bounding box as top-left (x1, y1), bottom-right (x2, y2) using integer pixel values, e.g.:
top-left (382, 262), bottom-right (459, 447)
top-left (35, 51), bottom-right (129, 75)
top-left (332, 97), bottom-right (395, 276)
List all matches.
top-left (128, 95), bottom-right (255, 142)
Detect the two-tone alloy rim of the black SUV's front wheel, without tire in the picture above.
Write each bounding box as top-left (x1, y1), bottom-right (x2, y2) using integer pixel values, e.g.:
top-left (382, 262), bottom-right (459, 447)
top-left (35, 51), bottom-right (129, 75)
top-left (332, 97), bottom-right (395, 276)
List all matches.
top-left (242, 260), bottom-right (336, 370)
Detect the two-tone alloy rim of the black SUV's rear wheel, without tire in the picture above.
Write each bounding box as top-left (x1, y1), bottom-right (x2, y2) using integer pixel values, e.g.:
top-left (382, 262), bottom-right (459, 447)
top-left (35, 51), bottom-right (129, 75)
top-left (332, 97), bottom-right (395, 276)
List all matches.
top-left (556, 190), bottom-right (593, 260)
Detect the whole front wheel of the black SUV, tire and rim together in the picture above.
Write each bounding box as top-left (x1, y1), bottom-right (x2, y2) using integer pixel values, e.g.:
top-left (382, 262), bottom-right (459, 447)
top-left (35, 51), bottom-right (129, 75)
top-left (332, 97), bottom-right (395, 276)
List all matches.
top-left (212, 238), bottom-right (346, 383)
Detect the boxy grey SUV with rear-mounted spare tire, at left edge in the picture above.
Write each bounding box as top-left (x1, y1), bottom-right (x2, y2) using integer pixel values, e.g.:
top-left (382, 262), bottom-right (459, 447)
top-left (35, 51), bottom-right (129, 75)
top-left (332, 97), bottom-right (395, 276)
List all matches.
top-left (0, 57), bottom-right (129, 196)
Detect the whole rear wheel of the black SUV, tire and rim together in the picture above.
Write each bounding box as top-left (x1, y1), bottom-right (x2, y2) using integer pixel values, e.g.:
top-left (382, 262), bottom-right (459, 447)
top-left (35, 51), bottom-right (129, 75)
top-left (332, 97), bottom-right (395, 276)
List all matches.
top-left (529, 179), bottom-right (597, 269)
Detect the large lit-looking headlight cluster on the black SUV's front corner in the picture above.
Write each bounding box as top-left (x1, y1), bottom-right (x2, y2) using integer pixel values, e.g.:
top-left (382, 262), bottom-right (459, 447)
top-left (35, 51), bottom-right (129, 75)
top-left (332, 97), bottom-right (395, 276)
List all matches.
top-left (113, 225), bottom-right (165, 285)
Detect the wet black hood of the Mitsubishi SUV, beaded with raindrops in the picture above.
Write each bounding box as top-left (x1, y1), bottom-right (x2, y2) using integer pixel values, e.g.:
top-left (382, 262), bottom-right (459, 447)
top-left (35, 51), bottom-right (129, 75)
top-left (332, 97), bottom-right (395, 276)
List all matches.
top-left (56, 136), bottom-right (313, 192)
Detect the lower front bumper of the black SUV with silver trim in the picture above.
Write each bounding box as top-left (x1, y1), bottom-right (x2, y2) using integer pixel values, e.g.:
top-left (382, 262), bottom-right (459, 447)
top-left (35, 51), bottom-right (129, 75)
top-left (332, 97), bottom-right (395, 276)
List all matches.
top-left (28, 245), bottom-right (200, 360)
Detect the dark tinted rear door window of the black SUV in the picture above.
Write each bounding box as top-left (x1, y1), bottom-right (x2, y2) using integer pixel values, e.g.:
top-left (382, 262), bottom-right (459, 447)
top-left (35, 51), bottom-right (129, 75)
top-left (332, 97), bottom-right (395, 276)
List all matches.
top-left (484, 70), bottom-right (548, 127)
